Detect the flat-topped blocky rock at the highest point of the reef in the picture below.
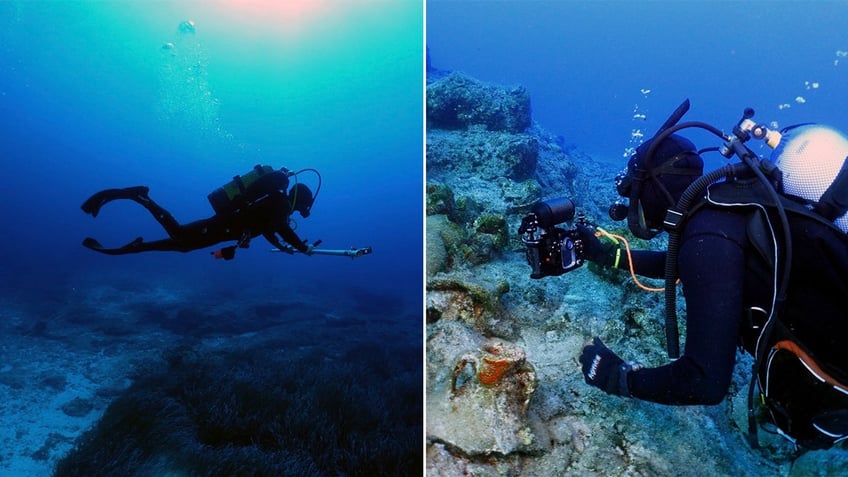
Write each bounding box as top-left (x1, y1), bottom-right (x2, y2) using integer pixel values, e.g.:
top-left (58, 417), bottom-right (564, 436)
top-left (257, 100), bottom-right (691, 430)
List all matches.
top-left (427, 73), bottom-right (530, 133)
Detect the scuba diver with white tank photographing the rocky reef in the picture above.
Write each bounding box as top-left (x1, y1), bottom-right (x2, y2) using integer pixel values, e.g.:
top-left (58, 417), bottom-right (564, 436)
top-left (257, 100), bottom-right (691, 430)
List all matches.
top-left (575, 100), bottom-right (848, 448)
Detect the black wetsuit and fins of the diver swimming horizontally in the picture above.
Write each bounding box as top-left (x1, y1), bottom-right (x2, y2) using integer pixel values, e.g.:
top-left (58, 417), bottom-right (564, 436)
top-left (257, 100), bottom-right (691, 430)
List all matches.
top-left (83, 187), bottom-right (308, 258)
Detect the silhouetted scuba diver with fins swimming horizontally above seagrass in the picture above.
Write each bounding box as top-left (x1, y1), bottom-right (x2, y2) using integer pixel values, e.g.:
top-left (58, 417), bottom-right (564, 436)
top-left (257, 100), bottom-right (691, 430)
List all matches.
top-left (82, 165), bottom-right (321, 260)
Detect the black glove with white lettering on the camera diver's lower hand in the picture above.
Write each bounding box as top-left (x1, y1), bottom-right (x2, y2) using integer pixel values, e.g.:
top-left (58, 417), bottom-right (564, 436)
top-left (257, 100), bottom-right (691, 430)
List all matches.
top-left (580, 336), bottom-right (642, 397)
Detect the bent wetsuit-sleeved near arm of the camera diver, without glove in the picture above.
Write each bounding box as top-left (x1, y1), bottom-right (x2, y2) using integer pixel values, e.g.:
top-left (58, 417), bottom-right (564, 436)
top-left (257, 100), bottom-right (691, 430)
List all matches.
top-left (628, 212), bottom-right (745, 404)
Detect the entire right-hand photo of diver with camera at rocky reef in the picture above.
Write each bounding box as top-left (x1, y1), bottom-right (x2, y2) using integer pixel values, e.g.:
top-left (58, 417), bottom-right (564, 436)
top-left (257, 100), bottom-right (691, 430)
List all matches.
top-left (425, 1), bottom-right (848, 476)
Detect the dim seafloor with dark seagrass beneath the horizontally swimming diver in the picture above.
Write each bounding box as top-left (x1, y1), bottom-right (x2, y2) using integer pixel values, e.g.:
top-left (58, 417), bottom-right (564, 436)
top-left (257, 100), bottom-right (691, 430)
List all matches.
top-left (0, 268), bottom-right (423, 477)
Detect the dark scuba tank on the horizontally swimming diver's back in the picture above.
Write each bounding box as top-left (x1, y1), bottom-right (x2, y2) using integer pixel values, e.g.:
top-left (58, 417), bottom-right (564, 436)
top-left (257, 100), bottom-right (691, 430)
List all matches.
top-left (207, 164), bottom-right (289, 214)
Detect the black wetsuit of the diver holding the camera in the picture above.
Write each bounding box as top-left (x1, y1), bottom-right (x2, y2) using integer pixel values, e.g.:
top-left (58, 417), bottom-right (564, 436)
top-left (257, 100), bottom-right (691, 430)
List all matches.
top-left (628, 207), bottom-right (848, 404)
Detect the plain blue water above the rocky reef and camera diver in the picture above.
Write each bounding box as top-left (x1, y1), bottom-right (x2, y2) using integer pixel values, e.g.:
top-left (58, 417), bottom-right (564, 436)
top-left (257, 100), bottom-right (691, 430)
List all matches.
top-left (426, 0), bottom-right (848, 169)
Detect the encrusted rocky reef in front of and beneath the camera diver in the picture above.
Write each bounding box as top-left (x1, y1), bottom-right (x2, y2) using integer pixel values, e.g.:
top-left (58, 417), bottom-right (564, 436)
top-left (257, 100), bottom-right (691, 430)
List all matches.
top-left (426, 71), bottom-right (848, 476)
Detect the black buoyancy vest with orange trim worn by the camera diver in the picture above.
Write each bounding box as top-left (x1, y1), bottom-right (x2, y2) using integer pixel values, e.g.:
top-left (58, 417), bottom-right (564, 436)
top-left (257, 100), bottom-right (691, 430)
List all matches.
top-left (687, 181), bottom-right (848, 448)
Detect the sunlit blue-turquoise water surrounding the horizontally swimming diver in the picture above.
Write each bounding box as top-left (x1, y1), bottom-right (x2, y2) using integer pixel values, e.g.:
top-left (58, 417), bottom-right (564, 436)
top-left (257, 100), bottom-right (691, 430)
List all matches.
top-left (0, 1), bottom-right (423, 307)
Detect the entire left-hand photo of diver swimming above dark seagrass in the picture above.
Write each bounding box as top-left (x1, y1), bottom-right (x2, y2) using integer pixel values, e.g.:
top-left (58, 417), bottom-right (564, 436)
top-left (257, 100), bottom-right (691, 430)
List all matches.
top-left (0, 1), bottom-right (424, 477)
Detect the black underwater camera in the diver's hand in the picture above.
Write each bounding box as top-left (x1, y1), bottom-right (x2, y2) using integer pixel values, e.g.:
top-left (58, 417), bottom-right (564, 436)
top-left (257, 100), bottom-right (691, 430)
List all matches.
top-left (518, 197), bottom-right (586, 278)
